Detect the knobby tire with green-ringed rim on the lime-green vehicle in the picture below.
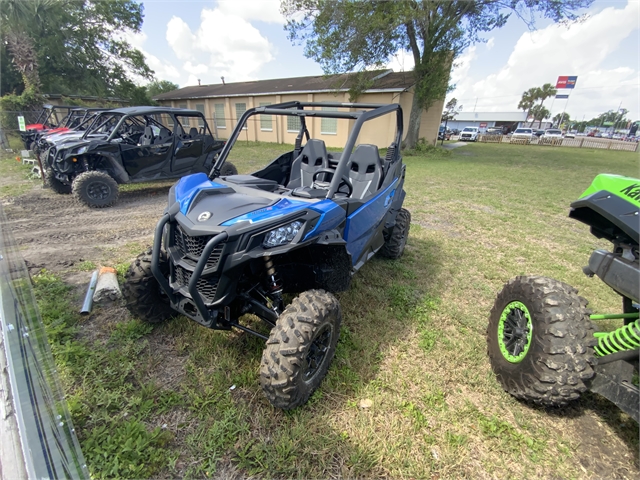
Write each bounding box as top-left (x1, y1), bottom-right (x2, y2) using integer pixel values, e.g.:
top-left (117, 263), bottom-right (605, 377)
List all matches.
top-left (487, 276), bottom-right (595, 406)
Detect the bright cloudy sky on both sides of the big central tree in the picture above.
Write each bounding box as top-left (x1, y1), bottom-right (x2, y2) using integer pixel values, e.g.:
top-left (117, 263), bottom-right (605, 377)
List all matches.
top-left (131, 0), bottom-right (640, 120)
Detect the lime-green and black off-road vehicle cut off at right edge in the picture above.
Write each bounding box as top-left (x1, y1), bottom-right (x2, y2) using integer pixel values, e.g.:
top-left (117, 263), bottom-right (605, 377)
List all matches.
top-left (487, 175), bottom-right (640, 421)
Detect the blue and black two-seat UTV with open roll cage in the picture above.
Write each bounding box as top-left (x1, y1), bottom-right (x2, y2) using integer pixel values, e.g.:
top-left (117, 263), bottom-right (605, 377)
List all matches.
top-left (123, 102), bottom-right (411, 409)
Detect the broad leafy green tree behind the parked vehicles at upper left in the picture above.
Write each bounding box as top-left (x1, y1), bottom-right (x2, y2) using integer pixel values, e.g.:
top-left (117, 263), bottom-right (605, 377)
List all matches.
top-left (0, 0), bottom-right (153, 100)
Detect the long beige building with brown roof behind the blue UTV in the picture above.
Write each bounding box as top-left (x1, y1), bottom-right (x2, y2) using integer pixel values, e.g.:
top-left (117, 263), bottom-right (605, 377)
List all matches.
top-left (154, 70), bottom-right (444, 147)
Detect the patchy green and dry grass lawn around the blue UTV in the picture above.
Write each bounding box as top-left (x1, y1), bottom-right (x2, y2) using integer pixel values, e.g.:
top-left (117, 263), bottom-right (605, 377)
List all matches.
top-left (28, 143), bottom-right (638, 478)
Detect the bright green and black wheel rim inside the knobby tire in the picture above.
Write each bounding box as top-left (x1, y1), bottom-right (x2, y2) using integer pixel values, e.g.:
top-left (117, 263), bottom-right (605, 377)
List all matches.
top-left (498, 302), bottom-right (533, 363)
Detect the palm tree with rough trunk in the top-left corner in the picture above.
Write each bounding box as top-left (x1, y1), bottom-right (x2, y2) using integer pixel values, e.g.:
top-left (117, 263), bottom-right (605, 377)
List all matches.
top-left (0, 0), bottom-right (65, 93)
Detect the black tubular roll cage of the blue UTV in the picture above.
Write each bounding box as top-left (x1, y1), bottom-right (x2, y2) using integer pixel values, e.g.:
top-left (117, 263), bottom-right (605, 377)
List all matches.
top-left (209, 101), bottom-right (403, 198)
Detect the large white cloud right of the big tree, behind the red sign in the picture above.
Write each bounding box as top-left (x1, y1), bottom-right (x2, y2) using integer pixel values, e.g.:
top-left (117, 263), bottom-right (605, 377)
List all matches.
top-left (449, 0), bottom-right (640, 119)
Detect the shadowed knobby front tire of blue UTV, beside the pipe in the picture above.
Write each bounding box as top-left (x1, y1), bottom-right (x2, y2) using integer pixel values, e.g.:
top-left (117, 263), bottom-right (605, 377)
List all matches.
top-left (122, 249), bottom-right (177, 323)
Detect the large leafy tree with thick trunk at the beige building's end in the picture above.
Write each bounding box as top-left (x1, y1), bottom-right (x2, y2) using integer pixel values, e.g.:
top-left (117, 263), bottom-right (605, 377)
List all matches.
top-left (281, 0), bottom-right (592, 148)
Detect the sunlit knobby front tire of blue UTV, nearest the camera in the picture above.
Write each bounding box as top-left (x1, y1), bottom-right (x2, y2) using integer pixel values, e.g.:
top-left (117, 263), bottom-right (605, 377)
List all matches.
top-left (260, 290), bottom-right (342, 410)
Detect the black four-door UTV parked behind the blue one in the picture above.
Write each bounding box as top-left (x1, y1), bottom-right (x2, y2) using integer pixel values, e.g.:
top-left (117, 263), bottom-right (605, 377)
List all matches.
top-left (45, 107), bottom-right (232, 208)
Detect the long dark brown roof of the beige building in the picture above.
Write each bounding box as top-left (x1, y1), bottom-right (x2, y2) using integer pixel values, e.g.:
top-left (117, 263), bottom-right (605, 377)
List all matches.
top-left (153, 70), bottom-right (414, 100)
